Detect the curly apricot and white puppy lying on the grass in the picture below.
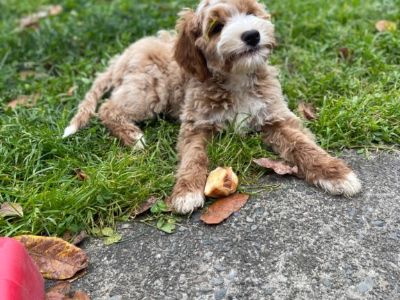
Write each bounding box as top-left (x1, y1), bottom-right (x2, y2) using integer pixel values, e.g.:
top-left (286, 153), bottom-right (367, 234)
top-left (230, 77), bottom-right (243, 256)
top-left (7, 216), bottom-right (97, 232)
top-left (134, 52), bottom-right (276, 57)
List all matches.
top-left (64, 0), bottom-right (361, 213)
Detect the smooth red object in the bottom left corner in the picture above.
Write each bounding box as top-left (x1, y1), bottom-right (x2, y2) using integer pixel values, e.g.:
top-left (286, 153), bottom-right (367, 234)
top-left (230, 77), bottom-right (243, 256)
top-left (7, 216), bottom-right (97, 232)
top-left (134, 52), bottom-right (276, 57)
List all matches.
top-left (0, 238), bottom-right (45, 300)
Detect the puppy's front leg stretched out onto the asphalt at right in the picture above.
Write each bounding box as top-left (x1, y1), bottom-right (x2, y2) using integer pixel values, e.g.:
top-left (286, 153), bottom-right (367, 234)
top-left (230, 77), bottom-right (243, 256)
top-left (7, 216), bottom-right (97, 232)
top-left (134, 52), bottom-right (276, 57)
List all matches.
top-left (262, 118), bottom-right (361, 196)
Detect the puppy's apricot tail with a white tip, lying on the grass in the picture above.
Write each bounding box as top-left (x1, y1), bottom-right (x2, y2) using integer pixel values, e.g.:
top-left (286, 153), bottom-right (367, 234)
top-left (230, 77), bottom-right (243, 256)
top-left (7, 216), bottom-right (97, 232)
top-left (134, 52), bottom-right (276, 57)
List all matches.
top-left (63, 64), bottom-right (113, 138)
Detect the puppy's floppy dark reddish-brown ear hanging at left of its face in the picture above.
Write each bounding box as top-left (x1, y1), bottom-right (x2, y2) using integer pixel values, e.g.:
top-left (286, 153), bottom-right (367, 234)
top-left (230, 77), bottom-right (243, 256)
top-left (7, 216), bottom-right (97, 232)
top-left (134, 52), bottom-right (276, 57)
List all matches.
top-left (174, 10), bottom-right (210, 81)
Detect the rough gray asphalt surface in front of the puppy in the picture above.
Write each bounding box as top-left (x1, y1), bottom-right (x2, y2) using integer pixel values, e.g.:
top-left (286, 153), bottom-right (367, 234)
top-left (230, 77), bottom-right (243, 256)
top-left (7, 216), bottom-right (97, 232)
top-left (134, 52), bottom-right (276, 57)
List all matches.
top-left (74, 152), bottom-right (400, 300)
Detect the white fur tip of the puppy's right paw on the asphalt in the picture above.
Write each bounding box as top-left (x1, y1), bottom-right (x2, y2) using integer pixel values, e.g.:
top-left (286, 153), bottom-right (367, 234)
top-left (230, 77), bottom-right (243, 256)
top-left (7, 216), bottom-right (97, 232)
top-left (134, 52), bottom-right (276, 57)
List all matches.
top-left (314, 172), bottom-right (361, 197)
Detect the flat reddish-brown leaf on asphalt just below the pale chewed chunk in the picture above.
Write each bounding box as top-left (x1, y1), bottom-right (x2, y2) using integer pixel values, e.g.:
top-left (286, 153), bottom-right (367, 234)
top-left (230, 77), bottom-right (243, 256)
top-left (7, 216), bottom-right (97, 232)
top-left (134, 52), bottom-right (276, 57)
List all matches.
top-left (200, 194), bottom-right (249, 224)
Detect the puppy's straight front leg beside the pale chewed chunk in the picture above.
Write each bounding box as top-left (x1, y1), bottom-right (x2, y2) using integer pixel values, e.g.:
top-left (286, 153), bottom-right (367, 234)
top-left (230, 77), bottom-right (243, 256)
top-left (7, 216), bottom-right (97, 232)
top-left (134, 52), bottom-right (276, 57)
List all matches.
top-left (171, 123), bottom-right (212, 214)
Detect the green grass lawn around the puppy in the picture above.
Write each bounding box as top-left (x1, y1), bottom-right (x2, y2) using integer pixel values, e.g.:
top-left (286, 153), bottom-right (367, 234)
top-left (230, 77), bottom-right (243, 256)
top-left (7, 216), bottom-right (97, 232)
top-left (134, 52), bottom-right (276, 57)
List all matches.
top-left (0, 0), bottom-right (400, 235)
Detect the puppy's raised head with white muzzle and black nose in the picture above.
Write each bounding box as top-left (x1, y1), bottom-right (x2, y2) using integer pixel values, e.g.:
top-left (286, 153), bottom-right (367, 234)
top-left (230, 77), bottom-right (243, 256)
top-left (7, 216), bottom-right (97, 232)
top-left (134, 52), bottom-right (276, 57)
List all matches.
top-left (175, 0), bottom-right (275, 81)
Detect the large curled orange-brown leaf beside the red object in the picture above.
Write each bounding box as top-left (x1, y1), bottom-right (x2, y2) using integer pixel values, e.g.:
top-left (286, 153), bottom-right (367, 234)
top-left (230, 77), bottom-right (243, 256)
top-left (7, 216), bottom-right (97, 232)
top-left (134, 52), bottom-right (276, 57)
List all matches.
top-left (14, 235), bottom-right (88, 280)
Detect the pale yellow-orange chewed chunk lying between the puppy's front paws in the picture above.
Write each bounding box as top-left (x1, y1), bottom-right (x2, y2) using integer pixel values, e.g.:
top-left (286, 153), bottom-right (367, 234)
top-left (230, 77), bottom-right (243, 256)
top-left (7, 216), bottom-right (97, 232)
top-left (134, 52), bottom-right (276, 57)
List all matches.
top-left (204, 167), bottom-right (239, 198)
